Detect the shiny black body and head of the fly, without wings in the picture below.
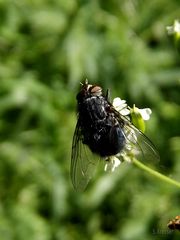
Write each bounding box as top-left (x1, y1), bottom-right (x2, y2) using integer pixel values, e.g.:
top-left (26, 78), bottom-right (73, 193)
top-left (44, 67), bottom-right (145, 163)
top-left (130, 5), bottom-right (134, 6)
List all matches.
top-left (77, 83), bottom-right (125, 157)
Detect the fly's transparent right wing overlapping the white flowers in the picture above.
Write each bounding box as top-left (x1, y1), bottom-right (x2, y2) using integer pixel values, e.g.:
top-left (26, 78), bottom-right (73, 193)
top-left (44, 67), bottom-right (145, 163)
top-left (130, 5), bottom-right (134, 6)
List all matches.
top-left (121, 116), bottom-right (160, 163)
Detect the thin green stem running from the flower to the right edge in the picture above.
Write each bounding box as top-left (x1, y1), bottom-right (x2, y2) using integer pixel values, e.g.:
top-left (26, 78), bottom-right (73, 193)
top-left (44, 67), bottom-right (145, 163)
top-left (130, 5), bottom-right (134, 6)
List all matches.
top-left (132, 158), bottom-right (180, 188)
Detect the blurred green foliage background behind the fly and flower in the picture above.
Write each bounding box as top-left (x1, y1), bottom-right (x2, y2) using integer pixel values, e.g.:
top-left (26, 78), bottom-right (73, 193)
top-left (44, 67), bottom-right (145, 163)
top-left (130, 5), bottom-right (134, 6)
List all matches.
top-left (0, 0), bottom-right (180, 240)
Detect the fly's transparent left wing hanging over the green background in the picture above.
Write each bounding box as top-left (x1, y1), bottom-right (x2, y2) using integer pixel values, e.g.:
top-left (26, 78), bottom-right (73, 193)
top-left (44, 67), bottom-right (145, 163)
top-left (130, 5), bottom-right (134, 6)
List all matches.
top-left (70, 121), bottom-right (98, 191)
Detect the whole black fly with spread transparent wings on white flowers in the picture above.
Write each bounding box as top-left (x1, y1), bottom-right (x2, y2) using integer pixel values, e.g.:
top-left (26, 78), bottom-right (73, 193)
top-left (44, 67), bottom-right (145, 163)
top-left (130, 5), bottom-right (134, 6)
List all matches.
top-left (71, 81), bottom-right (159, 190)
